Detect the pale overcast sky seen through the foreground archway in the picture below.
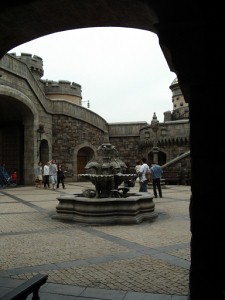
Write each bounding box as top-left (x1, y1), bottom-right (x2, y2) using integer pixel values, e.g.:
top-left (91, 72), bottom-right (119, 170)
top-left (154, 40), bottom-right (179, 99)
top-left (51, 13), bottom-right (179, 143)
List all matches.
top-left (9, 27), bottom-right (176, 123)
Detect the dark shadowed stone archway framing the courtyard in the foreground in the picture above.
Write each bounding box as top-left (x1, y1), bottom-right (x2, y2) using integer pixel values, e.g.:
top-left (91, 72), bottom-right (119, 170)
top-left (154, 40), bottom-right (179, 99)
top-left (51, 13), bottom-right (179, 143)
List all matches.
top-left (0, 0), bottom-right (225, 300)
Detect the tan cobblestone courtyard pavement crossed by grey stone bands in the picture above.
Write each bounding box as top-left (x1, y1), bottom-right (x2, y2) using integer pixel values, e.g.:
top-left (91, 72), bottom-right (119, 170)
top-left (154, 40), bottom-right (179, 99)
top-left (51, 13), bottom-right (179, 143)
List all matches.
top-left (0, 182), bottom-right (191, 300)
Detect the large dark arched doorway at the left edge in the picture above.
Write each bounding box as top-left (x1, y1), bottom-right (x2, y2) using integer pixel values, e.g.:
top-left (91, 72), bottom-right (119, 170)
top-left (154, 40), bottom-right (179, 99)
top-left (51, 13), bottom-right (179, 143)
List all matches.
top-left (0, 95), bottom-right (34, 184)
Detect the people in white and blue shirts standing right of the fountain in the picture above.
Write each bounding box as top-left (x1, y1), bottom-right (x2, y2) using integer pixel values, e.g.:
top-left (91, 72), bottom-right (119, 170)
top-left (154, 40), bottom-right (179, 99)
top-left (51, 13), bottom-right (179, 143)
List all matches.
top-left (135, 158), bottom-right (163, 198)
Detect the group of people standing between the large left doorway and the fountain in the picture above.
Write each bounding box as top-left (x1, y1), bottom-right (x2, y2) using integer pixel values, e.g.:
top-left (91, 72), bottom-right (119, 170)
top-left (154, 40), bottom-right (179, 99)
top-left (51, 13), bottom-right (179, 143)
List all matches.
top-left (35, 159), bottom-right (65, 190)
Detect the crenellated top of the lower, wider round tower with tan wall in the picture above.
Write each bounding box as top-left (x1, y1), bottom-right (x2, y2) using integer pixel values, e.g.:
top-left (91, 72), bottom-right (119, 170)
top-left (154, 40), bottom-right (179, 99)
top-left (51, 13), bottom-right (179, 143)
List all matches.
top-left (41, 79), bottom-right (81, 98)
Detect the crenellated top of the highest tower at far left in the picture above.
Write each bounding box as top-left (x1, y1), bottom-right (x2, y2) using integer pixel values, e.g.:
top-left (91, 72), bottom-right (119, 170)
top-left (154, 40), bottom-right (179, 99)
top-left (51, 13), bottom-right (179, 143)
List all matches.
top-left (9, 53), bottom-right (44, 78)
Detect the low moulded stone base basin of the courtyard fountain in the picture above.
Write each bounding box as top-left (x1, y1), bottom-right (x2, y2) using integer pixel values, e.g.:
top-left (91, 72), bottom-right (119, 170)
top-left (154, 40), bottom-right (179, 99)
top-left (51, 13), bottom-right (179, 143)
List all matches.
top-left (52, 193), bottom-right (158, 225)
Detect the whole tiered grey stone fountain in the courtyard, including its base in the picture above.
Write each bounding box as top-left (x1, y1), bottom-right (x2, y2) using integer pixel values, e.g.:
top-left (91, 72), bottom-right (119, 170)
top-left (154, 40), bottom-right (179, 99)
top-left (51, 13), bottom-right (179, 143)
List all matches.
top-left (53, 143), bottom-right (157, 225)
